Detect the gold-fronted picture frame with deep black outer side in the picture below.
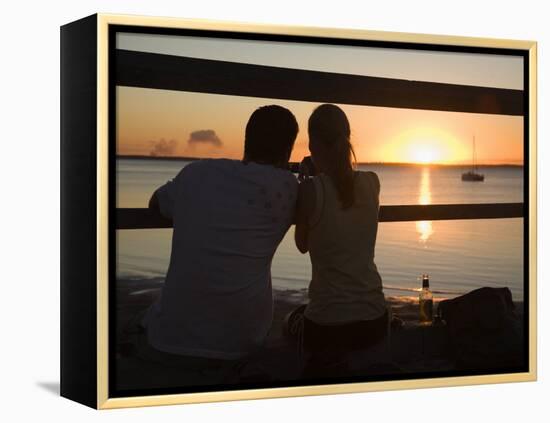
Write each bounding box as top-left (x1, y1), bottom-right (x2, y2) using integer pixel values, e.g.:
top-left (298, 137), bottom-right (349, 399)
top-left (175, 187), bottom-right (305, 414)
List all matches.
top-left (61, 14), bottom-right (537, 409)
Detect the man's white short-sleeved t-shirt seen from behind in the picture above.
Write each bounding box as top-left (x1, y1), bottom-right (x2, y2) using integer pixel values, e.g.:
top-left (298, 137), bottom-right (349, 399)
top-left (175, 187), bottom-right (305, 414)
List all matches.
top-left (144, 159), bottom-right (298, 359)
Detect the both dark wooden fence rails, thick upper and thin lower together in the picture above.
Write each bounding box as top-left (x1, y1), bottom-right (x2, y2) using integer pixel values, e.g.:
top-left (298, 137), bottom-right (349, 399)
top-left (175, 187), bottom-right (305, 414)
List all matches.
top-left (114, 50), bottom-right (524, 229)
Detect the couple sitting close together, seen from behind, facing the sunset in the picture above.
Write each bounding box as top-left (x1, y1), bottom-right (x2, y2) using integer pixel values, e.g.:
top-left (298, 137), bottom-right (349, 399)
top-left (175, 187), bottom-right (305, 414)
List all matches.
top-left (142, 104), bottom-right (387, 380)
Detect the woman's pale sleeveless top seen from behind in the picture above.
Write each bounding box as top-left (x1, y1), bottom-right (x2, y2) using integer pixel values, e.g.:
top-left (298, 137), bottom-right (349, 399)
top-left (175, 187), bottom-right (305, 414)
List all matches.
top-left (305, 171), bottom-right (386, 325)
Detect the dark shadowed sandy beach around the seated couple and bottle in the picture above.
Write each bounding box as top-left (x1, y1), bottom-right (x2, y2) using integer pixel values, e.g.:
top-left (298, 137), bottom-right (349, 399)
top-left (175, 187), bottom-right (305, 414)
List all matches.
top-left (115, 278), bottom-right (523, 393)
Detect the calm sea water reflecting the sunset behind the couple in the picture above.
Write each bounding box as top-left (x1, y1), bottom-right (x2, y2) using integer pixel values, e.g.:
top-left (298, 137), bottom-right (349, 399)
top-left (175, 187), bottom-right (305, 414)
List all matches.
top-left (116, 159), bottom-right (523, 300)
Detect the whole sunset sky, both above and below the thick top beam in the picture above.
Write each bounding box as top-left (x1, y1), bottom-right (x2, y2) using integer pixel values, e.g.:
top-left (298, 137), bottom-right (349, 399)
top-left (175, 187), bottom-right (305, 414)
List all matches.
top-left (117, 35), bottom-right (523, 164)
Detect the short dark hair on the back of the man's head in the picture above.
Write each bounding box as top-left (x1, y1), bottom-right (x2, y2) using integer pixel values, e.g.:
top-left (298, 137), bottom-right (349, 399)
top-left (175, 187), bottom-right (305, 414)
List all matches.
top-left (244, 105), bottom-right (298, 164)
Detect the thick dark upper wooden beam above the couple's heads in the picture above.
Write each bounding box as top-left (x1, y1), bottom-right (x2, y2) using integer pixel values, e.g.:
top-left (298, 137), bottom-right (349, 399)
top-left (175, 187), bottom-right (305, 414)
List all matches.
top-left (114, 50), bottom-right (524, 116)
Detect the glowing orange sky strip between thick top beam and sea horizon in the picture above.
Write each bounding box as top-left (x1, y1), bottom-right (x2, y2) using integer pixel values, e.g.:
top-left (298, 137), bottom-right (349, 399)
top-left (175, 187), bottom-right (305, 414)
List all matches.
top-left (117, 87), bottom-right (523, 164)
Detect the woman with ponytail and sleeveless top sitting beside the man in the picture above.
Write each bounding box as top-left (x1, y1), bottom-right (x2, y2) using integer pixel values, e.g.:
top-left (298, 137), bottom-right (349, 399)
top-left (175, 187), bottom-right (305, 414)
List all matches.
top-left (287, 104), bottom-right (388, 373)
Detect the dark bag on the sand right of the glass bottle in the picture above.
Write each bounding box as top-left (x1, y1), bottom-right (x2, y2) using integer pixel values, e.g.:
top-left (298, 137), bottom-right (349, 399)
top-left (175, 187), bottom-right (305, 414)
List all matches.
top-left (439, 287), bottom-right (525, 370)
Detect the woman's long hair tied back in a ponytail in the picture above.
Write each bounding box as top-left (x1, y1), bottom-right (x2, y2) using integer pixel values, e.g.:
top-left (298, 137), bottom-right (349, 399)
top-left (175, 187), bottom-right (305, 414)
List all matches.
top-left (308, 104), bottom-right (356, 209)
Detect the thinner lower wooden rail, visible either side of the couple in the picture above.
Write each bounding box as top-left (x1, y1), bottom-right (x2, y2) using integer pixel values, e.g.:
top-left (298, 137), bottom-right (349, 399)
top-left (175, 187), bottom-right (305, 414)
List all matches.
top-left (115, 203), bottom-right (524, 229)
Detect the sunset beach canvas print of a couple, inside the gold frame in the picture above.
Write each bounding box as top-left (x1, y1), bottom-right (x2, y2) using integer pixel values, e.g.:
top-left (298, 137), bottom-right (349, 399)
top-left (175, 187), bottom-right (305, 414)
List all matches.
top-left (109, 27), bottom-right (528, 397)
